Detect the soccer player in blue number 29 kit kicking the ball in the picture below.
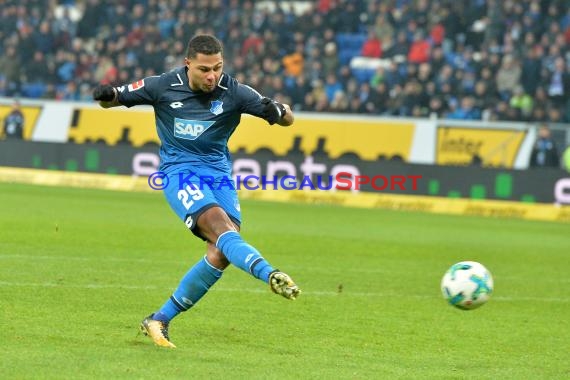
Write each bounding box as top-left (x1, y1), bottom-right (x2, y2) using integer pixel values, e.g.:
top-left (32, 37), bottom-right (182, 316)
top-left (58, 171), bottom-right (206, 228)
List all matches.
top-left (93, 35), bottom-right (301, 348)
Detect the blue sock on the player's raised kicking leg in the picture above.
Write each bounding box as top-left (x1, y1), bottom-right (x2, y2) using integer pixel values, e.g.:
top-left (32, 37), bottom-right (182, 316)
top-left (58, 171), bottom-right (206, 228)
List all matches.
top-left (216, 231), bottom-right (273, 283)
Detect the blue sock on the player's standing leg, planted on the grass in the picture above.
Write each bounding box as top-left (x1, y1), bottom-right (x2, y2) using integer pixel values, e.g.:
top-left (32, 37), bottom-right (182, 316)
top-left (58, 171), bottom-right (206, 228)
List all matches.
top-left (153, 256), bottom-right (223, 322)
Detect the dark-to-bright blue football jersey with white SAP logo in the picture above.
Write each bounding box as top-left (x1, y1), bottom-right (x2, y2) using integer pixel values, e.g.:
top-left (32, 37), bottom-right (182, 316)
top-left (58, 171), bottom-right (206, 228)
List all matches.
top-left (116, 66), bottom-right (263, 173)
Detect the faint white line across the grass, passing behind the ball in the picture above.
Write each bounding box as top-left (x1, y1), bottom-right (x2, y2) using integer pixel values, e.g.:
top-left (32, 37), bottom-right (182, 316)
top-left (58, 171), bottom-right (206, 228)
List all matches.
top-left (0, 281), bottom-right (570, 303)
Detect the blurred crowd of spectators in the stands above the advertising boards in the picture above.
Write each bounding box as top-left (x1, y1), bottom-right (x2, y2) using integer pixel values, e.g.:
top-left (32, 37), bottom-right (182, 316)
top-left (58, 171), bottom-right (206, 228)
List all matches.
top-left (0, 0), bottom-right (570, 123)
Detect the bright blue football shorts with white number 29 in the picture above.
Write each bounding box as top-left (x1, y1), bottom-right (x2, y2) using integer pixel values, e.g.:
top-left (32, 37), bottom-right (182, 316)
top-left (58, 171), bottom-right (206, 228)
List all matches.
top-left (163, 166), bottom-right (241, 240)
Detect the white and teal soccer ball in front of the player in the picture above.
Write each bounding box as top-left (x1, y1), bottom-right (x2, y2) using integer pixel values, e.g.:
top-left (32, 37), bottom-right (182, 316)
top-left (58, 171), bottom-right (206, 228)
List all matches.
top-left (441, 261), bottom-right (493, 310)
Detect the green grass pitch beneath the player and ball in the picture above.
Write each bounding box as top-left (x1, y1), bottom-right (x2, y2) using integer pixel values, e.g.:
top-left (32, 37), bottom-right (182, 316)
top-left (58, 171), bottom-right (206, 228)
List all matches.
top-left (0, 184), bottom-right (570, 379)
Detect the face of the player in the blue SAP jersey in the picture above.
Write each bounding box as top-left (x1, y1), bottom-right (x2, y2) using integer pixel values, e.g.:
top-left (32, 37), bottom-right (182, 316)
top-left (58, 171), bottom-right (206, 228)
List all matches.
top-left (184, 53), bottom-right (224, 92)
